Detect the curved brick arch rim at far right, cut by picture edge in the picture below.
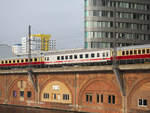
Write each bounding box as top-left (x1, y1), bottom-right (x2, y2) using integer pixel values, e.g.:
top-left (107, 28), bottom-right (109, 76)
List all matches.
top-left (127, 77), bottom-right (150, 104)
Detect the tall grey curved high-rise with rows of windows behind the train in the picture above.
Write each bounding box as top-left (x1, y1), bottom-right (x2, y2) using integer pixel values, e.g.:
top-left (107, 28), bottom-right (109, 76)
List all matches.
top-left (84, 0), bottom-right (150, 48)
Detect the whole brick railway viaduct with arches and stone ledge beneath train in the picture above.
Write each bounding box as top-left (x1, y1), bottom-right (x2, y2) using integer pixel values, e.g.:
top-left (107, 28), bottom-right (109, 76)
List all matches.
top-left (0, 64), bottom-right (150, 113)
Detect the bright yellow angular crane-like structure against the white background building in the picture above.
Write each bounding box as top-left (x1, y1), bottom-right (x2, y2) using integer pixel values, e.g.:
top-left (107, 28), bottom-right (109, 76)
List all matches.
top-left (31, 34), bottom-right (51, 51)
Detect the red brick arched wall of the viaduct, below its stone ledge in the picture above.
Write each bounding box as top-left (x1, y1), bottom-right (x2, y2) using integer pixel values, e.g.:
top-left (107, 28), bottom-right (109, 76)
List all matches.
top-left (0, 71), bottom-right (150, 113)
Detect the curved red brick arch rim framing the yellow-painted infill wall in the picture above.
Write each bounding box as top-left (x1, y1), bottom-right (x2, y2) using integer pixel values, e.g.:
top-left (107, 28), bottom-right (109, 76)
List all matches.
top-left (40, 77), bottom-right (74, 103)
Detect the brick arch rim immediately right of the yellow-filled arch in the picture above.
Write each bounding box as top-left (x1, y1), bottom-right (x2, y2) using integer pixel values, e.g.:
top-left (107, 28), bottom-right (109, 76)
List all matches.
top-left (78, 78), bottom-right (122, 104)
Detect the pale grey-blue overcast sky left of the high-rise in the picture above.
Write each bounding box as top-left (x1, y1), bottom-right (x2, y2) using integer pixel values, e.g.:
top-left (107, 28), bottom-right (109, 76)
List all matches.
top-left (0, 0), bottom-right (84, 49)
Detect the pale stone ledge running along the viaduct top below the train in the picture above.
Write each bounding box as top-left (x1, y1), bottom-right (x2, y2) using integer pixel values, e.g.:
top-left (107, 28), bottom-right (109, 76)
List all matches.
top-left (0, 64), bottom-right (150, 74)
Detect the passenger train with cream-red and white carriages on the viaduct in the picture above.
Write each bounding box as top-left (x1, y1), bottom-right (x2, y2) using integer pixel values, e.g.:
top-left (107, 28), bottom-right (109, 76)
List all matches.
top-left (0, 44), bottom-right (150, 69)
